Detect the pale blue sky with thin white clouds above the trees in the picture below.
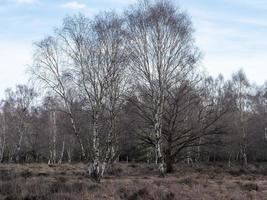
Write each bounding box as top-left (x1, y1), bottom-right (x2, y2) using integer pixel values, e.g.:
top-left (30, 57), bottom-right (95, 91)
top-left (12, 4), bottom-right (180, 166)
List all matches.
top-left (0, 0), bottom-right (267, 97)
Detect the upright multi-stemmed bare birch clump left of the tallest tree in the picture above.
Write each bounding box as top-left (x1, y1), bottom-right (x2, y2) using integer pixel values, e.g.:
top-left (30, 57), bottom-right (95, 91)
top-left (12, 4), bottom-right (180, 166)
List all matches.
top-left (60, 13), bottom-right (126, 181)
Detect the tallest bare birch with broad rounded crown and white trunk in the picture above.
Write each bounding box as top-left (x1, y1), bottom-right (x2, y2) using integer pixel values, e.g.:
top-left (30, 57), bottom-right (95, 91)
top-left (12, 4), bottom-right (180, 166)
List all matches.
top-left (126, 1), bottom-right (199, 175)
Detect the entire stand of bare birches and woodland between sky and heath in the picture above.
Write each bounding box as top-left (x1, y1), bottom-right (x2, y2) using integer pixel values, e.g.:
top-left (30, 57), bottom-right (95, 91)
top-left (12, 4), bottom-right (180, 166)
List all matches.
top-left (0, 0), bottom-right (267, 181)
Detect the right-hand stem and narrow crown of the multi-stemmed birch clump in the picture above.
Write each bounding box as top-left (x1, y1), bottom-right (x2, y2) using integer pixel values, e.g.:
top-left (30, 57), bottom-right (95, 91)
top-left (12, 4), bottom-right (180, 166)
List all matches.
top-left (94, 13), bottom-right (129, 170)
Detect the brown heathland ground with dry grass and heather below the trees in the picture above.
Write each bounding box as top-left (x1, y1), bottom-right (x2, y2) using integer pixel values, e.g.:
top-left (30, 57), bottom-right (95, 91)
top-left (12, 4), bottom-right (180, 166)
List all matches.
top-left (0, 163), bottom-right (267, 200)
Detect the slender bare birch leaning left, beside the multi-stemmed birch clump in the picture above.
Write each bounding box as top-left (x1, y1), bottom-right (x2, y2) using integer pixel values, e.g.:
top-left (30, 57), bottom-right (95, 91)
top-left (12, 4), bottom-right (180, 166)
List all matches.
top-left (31, 37), bottom-right (86, 159)
